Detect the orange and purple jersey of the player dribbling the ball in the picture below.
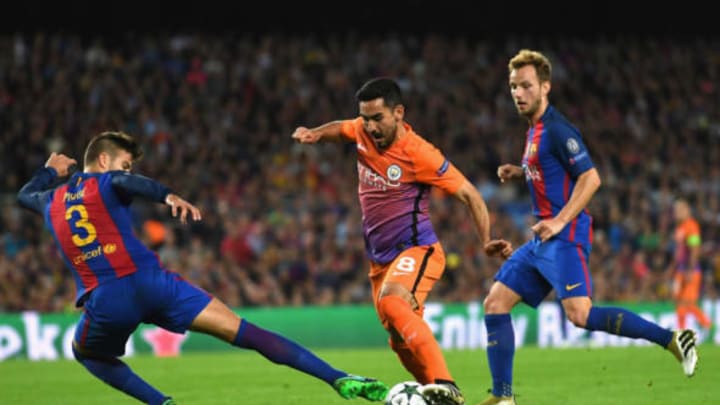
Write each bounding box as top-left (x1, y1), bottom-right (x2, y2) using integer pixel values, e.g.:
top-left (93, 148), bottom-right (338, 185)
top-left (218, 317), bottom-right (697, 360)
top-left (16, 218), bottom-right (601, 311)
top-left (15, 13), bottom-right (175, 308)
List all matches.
top-left (341, 118), bottom-right (465, 264)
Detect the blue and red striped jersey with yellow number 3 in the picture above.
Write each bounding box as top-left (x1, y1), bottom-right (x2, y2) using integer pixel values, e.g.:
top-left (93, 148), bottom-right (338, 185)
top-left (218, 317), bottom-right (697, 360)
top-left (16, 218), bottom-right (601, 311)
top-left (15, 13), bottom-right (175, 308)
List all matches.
top-left (18, 168), bottom-right (170, 306)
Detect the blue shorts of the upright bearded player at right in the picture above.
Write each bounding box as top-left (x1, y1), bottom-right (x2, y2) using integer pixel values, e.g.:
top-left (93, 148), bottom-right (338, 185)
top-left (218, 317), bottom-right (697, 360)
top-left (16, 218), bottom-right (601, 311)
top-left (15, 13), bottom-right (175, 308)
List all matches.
top-left (495, 238), bottom-right (592, 308)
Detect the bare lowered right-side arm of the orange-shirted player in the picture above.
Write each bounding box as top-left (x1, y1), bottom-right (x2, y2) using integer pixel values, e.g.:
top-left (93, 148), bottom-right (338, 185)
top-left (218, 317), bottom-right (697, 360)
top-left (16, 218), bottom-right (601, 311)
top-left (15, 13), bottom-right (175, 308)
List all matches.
top-left (454, 180), bottom-right (512, 259)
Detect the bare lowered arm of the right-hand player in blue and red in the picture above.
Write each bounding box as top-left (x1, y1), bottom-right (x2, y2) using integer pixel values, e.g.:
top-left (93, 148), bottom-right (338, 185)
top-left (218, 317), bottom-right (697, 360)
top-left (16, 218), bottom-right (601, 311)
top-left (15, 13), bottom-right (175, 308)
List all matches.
top-left (532, 168), bottom-right (601, 242)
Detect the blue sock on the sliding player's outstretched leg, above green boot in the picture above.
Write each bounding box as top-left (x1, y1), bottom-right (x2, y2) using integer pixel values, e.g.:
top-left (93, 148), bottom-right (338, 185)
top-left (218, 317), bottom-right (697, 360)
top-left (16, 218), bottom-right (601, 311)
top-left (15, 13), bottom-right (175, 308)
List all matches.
top-left (233, 319), bottom-right (348, 385)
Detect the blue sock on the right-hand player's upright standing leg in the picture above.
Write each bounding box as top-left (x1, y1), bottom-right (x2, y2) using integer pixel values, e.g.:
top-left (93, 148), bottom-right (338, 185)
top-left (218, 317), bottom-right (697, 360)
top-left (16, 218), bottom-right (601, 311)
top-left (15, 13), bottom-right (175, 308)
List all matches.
top-left (485, 314), bottom-right (515, 397)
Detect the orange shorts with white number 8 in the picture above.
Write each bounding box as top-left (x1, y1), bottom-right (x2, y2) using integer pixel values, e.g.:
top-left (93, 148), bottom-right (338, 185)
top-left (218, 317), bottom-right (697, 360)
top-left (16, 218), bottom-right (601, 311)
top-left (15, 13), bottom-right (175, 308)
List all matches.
top-left (370, 242), bottom-right (445, 315)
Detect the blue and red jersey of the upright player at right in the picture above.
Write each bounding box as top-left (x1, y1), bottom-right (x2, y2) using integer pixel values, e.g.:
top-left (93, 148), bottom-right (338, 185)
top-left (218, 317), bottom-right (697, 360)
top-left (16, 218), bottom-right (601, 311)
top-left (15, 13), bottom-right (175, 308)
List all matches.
top-left (522, 106), bottom-right (594, 245)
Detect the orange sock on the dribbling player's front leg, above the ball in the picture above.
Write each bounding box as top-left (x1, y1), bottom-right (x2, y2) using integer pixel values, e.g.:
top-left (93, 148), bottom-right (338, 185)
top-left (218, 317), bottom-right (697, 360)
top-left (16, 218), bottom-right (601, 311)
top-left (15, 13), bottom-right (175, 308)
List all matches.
top-left (377, 295), bottom-right (453, 382)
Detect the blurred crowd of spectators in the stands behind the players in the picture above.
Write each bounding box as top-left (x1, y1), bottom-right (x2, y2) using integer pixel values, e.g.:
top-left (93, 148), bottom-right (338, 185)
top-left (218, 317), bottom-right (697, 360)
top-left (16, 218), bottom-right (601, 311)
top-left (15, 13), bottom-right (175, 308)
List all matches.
top-left (0, 33), bottom-right (720, 312)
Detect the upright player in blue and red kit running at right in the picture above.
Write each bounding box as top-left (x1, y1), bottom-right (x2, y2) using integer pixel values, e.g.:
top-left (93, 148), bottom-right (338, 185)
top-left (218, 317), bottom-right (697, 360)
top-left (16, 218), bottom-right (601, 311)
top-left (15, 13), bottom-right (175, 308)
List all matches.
top-left (480, 49), bottom-right (697, 405)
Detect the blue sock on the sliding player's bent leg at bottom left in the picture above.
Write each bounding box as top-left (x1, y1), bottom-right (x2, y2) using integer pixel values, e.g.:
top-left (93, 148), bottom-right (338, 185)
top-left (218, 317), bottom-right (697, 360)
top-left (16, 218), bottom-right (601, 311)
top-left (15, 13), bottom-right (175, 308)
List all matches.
top-left (73, 348), bottom-right (168, 405)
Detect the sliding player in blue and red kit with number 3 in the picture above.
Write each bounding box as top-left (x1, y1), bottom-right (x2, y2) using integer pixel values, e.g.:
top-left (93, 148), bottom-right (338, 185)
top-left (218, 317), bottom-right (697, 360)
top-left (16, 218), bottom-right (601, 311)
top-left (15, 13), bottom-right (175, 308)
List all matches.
top-left (18, 132), bottom-right (388, 405)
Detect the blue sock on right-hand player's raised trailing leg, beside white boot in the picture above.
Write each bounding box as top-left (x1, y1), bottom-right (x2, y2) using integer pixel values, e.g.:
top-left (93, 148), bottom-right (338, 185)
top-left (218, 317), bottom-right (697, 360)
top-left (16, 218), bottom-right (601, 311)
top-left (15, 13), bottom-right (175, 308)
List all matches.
top-left (585, 306), bottom-right (672, 348)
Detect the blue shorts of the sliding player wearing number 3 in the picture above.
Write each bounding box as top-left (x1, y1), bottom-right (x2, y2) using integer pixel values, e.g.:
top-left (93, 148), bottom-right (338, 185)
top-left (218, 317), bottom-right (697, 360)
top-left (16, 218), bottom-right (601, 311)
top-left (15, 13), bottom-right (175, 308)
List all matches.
top-left (75, 268), bottom-right (212, 357)
